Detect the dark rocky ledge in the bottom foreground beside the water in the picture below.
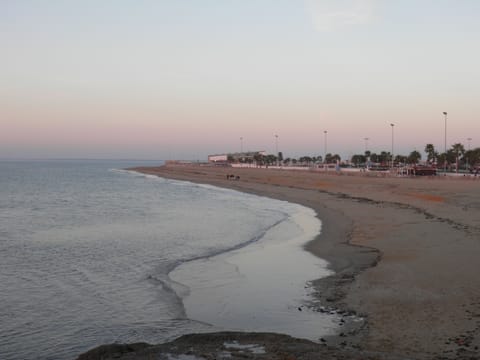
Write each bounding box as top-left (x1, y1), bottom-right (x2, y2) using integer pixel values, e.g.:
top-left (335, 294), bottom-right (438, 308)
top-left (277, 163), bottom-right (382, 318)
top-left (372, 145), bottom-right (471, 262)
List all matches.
top-left (78, 332), bottom-right (414, 360)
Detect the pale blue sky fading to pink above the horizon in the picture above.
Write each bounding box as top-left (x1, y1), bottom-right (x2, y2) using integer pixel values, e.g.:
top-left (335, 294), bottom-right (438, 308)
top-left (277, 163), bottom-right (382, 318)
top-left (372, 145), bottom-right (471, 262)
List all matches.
top-left (0, 0), bottom-right (480, 160)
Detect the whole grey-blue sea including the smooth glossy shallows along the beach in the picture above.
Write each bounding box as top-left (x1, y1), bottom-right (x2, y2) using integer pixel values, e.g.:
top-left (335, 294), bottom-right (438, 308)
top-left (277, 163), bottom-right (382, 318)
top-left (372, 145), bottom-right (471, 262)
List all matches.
top-left (0, 160), bottom-right (336, 360)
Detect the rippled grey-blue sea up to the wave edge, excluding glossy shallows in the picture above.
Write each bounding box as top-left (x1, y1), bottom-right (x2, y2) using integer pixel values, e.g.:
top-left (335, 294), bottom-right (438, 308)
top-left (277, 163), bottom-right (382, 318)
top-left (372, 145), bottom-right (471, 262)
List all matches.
top-left (0, 161), bottom-right (330, 360)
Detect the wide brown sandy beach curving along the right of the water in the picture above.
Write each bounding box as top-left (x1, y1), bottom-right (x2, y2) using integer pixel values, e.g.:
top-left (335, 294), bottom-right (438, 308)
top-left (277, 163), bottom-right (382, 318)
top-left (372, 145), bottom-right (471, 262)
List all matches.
top-left (79, 165), bottom-right (480, 359)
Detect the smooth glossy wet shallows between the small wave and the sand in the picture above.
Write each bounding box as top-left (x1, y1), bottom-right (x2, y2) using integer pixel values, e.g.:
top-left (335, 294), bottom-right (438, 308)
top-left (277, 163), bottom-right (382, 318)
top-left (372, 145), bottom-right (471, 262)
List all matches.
top-left (169, 201), bottom-right (340, 343)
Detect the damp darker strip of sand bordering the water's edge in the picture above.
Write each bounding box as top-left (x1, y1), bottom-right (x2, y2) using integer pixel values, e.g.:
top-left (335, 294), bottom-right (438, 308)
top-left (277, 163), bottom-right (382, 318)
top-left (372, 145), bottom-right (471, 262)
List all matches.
top-left (134, 166), bottom-right (380, 348)
